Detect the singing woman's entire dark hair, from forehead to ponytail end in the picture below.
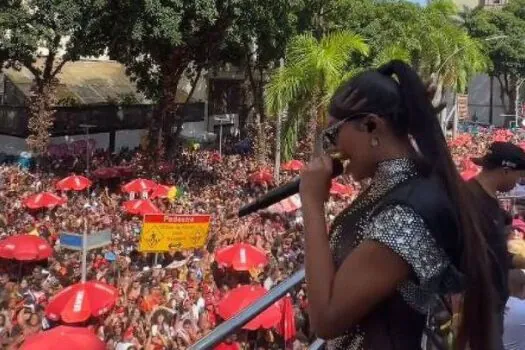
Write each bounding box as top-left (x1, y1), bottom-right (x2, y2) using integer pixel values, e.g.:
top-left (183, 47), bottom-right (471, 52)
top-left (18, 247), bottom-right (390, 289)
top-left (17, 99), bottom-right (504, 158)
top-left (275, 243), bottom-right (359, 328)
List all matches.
top-left (329, 61), bottom-right (495, 350)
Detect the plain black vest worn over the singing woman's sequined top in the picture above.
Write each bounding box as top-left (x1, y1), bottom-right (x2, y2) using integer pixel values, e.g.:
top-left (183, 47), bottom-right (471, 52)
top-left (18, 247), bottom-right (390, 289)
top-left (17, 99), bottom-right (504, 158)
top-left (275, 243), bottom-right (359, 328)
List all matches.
top-left (333, 171), bottom-right (462, 350)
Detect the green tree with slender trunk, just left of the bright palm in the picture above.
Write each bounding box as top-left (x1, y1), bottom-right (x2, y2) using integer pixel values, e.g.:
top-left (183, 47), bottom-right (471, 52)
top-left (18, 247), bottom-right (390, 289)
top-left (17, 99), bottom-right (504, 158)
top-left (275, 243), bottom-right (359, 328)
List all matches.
top-left (219, 0), bottom-right (298, 163)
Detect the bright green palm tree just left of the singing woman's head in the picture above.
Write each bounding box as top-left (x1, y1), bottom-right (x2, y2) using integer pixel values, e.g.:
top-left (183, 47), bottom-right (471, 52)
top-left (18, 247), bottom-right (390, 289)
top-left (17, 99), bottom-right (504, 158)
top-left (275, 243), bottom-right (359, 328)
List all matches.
top-left (265, 31), bottom-right (369, 159)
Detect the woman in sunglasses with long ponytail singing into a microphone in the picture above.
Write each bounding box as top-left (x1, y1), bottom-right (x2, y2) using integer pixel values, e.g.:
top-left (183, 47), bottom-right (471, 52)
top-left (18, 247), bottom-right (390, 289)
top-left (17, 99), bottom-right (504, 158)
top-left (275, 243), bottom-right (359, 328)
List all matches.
top-left (300, 61), bottom-right (501, 350)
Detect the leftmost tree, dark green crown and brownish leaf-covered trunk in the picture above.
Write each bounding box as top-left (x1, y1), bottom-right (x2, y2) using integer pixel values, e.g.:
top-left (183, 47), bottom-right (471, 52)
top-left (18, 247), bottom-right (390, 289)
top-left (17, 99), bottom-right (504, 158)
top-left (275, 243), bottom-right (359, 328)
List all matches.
top-left (0, 0), bottom-right (105, 154)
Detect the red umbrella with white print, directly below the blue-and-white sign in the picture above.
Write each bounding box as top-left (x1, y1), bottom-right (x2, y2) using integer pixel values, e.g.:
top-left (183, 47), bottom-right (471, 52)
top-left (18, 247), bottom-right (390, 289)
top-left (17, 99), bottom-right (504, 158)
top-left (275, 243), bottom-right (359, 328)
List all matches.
top-left (46, 281), bottom-right (118, 323)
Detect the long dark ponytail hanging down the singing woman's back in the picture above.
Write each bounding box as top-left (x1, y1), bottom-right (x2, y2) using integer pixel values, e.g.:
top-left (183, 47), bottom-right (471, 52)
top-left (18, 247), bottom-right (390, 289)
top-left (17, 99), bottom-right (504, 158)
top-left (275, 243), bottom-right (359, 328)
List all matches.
top-left (379, 61), bottom-right (495, 350)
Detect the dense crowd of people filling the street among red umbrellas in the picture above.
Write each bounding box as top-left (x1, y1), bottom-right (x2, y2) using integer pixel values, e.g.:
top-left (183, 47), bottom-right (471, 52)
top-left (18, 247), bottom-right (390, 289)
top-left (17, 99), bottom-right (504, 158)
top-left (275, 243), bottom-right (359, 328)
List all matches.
top-left (0, 126), bottom-right (523, 350)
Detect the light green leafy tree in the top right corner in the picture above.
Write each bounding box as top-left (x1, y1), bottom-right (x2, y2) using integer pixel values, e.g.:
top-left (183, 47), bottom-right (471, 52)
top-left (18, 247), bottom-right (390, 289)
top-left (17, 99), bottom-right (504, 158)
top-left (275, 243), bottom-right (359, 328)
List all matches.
top-left (465, 0), bottom-right (525, 114)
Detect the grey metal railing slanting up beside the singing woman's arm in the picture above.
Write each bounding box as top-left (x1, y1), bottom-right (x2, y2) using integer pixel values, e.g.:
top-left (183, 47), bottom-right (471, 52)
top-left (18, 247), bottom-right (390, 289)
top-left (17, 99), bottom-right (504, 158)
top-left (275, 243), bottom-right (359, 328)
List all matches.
top-left (186, 269), bottom-right (324, 350)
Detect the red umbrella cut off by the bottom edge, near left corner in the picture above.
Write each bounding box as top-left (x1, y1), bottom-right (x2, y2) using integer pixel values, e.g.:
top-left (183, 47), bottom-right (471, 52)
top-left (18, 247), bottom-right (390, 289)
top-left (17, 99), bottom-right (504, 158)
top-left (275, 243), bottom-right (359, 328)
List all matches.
top-left (20, 326), bottom-right (106, 350)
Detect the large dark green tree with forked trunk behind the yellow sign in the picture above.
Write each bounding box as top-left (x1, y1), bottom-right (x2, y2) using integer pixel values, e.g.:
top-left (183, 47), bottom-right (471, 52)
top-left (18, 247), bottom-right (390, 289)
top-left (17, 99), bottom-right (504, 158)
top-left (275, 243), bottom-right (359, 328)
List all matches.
top-left (101, 0), bottom-right (246, 154)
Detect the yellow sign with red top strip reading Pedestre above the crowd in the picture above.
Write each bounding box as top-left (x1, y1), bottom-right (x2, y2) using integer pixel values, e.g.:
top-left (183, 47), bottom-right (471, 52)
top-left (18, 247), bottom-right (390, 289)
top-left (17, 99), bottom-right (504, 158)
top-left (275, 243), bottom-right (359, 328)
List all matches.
top-left (139, 214), bottom-right (210, 253)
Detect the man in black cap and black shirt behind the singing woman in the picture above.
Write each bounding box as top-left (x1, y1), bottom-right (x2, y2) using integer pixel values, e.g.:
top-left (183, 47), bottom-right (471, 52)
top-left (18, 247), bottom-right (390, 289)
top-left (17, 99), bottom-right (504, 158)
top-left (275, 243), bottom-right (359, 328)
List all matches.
top-left (468, 142), bottom-right (525, 348)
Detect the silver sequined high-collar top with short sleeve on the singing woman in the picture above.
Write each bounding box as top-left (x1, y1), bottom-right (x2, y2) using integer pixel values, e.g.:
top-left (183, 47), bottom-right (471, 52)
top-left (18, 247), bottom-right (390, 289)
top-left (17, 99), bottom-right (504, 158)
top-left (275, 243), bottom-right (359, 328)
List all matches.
top-left (328, 159), bottom-right (459, 350)
